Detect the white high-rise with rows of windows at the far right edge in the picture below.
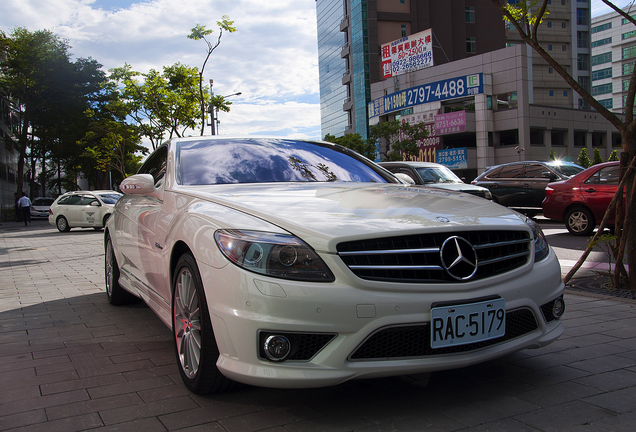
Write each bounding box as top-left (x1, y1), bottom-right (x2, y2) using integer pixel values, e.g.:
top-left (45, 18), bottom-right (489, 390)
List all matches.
top-left (591, 9), bottom-right (636, 113)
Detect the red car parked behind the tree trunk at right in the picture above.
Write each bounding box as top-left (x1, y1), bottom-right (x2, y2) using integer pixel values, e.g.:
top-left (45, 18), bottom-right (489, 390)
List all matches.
top-left (543, 162), bottom-right (624, 236)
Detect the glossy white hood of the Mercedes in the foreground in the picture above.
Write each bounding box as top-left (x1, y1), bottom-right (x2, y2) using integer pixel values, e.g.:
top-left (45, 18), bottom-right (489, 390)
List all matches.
top-left (179, 182), bottom-right (527, 251)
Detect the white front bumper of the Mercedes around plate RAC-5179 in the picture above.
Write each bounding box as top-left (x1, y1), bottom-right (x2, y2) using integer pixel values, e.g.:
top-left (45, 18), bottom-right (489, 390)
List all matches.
top-left (200, 248), bottom-right (564, 388)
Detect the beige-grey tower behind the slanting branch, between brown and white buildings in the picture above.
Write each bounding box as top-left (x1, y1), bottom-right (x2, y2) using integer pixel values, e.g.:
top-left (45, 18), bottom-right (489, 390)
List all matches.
top-left (506, 0), bottom-right (591, 108)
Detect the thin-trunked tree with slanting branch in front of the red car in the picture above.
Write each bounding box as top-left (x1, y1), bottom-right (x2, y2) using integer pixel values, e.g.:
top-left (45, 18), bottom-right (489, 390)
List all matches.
top-left (492, 0), bottom-right (636, 290)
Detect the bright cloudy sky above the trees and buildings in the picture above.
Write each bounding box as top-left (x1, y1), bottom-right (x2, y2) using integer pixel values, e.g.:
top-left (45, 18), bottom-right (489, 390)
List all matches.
top-left (0, 0), bottom-right (631, 143)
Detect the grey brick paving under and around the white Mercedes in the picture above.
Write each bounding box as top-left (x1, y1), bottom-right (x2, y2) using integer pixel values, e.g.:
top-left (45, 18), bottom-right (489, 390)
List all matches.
top-left (0, 221), bottom-right (636, 432)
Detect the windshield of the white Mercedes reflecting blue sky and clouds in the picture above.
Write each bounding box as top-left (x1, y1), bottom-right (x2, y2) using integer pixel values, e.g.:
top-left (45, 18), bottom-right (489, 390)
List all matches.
top-left (177, 138), bottom-right (397, 185)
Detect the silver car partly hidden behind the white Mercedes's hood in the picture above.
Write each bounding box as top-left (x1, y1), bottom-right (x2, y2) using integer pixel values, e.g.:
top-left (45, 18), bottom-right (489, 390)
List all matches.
top-left (379, 162), bottom-right (492, 199)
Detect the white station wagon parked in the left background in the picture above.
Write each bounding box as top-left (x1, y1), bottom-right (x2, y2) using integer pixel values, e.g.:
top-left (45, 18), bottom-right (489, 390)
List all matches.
top-left (49, 190), bottom-right (122, 232)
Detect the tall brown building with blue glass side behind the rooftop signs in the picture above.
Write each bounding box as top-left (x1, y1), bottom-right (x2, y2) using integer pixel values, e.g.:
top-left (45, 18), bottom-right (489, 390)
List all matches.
top-left (316, 0), bottom-right (506, 137)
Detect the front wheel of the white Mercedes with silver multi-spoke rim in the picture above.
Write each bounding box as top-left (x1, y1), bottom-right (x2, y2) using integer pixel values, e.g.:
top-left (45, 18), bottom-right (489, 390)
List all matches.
top-left (172, 253), bottom-right (235, 394)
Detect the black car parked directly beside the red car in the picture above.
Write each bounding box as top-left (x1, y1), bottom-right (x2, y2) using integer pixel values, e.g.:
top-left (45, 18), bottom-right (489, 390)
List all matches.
top-left (471, 161), bottom-right (584, 216)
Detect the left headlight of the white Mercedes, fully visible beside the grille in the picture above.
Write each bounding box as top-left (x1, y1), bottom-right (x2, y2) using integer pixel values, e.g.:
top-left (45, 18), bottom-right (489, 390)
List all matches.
top-left (214, 229), bottom-right (335, 282)
